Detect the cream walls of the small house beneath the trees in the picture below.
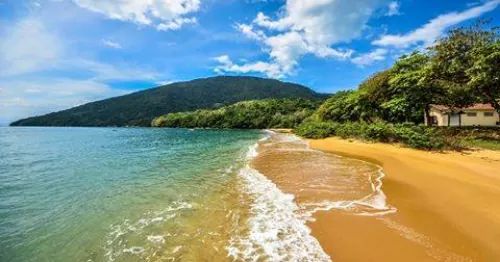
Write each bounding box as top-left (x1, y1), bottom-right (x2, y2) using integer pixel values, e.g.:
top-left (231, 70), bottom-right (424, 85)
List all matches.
top-left (430, 109), bottom-right (498, 126)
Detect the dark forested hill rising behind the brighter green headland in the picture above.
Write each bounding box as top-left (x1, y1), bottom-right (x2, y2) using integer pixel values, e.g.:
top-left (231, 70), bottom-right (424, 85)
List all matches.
top-left (11, 76), bottom-right (325, 126)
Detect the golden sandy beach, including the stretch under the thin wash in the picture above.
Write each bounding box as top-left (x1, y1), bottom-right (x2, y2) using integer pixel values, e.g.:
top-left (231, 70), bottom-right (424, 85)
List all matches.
top-left (253, 134), bottom-right (500, 262)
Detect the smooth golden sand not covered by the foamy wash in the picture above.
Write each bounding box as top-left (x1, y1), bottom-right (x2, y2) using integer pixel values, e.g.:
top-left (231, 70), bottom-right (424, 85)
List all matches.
top-left (308, 138), bottom-right (500, 262)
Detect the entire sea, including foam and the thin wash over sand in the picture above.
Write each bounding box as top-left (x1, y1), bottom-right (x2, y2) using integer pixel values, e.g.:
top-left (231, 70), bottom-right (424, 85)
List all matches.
top-left (0, 127), bottom-right (391, 262)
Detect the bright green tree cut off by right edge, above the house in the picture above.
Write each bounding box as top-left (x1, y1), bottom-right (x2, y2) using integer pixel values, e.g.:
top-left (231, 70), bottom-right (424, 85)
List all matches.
top-left (467, 41), bottom-right (500, 121)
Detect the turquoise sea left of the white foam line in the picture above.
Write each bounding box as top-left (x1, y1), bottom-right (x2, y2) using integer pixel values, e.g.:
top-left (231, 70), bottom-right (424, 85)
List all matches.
top-left (0, 128), bottom-right (262, 261)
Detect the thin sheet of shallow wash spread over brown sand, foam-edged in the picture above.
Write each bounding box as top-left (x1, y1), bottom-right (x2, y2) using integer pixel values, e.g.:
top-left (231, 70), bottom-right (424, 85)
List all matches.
top-left (252, 134), bottom-right (396, 219)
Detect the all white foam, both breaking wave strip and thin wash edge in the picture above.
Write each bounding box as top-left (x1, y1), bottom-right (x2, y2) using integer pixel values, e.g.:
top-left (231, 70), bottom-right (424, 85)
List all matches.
top-left (227, 134), bottom-right (397, 261)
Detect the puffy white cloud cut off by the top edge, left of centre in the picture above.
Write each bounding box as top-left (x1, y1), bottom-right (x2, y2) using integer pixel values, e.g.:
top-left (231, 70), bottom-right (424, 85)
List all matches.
top-left (73, 0), bottom-right (200, 30)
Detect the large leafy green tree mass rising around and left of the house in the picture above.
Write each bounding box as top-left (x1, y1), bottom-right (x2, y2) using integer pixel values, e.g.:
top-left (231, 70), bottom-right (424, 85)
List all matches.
top-left (316, 22), bottom-right (500, 123)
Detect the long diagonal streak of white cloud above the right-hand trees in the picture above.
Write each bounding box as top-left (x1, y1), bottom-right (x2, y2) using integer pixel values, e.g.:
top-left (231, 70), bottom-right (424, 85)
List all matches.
top-left (373, 0), bottom-right (500, 48)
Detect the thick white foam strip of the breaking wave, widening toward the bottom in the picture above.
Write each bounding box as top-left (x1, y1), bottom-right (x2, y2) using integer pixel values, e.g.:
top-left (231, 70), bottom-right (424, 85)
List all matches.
top-left (227, 141), bottom-right (330, 261)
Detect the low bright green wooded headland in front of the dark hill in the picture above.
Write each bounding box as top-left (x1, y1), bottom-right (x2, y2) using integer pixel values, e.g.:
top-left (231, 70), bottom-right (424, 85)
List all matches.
top-left (151, 99), bottom-right (320, 129)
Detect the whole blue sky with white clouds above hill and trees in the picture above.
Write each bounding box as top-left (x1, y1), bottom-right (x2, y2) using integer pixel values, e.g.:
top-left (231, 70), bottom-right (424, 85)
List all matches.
top-left (0, 0), bottom-right (500, 125)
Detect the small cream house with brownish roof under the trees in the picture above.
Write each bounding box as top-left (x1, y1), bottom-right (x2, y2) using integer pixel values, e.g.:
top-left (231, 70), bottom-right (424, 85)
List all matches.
top-left (424, 104), bottom-right (500, 126)
